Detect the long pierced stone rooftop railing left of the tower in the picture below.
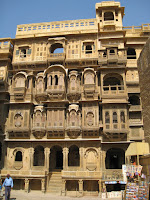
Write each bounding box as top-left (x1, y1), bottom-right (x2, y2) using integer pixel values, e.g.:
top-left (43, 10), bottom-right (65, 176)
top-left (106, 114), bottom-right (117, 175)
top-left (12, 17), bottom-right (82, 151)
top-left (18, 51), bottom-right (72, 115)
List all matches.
top-left (16, 19), bottom-right (98, 38)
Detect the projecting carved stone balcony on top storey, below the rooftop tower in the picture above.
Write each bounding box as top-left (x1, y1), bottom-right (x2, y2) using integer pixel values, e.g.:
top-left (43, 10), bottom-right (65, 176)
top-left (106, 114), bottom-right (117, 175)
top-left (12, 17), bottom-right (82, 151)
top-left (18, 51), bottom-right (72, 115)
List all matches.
top-left (98, 49), bottom-right (127, 67)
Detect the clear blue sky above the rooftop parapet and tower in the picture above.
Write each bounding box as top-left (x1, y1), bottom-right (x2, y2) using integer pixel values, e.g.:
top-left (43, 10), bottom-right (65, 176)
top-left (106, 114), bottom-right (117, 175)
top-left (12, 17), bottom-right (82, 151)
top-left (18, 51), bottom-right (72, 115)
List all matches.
top-left (0, 0), bottom-right (150, 38)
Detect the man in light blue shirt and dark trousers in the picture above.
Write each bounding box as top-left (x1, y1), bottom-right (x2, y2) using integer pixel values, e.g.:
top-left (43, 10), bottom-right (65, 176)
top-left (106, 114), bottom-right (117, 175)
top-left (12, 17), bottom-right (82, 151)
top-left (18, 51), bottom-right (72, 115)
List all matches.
top-left (3, 174), bottom-right (13, 200)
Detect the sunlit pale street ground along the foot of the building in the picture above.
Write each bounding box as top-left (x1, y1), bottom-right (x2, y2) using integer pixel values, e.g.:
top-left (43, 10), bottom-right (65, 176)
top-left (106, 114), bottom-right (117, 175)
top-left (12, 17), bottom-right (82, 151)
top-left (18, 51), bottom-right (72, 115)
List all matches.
top-left (0, 190), bottom-right (121, 200)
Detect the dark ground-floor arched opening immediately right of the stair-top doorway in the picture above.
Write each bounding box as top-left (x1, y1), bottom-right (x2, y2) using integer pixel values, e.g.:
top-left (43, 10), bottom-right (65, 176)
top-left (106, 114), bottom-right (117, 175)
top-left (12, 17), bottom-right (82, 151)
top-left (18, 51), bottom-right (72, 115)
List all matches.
top-left (68, 145), bottom-right (80, 166)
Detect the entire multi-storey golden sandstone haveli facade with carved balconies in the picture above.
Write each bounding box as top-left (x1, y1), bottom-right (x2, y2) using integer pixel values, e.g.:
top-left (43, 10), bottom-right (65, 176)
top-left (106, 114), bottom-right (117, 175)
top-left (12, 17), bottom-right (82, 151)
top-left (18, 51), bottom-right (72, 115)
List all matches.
top-left (0, 1), bottom-right (150, 196)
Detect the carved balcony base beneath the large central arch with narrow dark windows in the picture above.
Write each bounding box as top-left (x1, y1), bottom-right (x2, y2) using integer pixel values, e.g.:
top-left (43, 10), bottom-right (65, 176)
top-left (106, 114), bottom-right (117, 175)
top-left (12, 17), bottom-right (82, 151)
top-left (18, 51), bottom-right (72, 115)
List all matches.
top-left (46, 85), bottom-right (65, 99)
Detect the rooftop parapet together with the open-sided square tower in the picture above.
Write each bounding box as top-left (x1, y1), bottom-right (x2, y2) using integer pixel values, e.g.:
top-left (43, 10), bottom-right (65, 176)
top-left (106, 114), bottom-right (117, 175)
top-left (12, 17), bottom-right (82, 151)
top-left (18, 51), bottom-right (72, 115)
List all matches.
top-left (16, 1), bottom-right (150, 38)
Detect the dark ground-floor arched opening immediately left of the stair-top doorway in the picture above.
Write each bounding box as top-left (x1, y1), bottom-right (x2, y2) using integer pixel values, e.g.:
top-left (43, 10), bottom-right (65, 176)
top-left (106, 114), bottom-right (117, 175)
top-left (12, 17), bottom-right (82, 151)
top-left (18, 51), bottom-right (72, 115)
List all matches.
top-left (33, 146), bottom-right (45, 166)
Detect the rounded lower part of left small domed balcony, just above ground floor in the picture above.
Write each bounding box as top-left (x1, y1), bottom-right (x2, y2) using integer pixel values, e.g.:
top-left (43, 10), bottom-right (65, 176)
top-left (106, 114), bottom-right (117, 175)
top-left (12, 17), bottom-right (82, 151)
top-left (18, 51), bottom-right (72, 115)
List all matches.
top-left (32, 122), bottom-right (46, 139)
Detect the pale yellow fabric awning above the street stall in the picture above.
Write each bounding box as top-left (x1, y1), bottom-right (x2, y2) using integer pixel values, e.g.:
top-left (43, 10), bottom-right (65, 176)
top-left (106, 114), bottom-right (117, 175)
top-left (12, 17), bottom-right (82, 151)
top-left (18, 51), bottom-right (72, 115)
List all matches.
top-left (125, 142), bottom-right (149, 157)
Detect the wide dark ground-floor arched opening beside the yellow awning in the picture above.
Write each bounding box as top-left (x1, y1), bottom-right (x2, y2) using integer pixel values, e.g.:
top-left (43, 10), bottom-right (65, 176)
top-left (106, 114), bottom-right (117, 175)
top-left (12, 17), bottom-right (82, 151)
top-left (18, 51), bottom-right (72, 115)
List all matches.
top-left (105, 148), bottom-right (125, 169)
